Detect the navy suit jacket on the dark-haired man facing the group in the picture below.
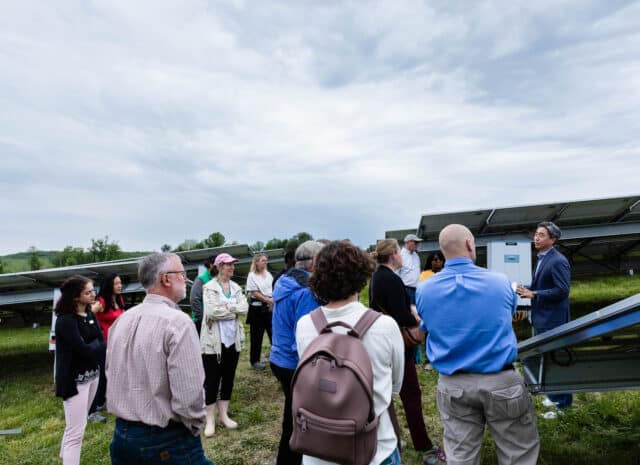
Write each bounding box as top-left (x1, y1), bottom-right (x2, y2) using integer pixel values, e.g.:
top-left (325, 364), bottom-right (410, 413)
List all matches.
top-left (530, 248), bottom-right (571, 332)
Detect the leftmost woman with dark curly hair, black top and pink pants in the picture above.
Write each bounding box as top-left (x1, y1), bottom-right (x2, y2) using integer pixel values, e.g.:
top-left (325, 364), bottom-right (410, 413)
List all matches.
top-left (55, 276), bottom-right (105, 465)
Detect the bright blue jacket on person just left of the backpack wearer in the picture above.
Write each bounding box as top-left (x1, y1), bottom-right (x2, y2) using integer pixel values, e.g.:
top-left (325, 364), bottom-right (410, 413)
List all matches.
top-left (269, 268), bottom-right (320, 370)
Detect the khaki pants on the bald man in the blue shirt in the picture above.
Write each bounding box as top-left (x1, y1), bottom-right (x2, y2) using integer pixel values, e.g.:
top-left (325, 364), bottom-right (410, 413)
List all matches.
top-left (438, 370), bottom-right (540, 465)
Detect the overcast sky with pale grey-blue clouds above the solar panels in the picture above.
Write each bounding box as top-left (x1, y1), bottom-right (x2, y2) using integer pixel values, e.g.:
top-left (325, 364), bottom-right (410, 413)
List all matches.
top-left (0, 0), bottom-right (640, 255)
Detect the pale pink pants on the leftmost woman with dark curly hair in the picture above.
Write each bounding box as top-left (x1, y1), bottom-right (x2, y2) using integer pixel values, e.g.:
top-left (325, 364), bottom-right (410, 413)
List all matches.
top-left (60, 378), bottom-right (98, 465)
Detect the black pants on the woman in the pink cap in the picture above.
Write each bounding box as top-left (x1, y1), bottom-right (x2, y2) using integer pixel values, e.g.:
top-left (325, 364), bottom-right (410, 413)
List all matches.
top-left (202, 344), bottom-right (240, 405)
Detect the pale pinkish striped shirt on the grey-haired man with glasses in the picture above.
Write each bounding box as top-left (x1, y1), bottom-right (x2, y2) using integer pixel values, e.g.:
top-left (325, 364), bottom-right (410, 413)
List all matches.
top-left (106, 294), bottom-right (205, 436)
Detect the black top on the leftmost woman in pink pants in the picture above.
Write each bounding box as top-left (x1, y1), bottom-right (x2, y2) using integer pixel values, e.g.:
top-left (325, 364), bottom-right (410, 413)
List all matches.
top-left (55, 308), bottom-right (105, 399)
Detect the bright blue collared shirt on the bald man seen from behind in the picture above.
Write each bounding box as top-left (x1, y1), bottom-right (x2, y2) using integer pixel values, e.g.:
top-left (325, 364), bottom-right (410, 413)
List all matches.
top-left (416, 257), bottom-right (518, 375)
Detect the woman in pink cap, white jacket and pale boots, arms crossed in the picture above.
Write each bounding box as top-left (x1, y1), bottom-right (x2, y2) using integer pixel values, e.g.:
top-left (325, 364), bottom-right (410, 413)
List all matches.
top-left (200, 253), bottom-right (249, 437)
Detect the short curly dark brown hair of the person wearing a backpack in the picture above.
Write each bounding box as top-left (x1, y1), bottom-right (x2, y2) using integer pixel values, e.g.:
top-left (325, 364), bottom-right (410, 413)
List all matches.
top-left (309, 241), bottom-right (375, 302)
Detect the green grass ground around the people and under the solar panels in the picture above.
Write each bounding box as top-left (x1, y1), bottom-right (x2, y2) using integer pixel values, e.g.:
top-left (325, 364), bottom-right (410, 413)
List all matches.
top-left (0, 278), bottom-right (640, 465)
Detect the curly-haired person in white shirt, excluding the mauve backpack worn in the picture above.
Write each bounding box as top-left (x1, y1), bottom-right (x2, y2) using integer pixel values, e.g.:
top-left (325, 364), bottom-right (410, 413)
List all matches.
top-left (296, 241), bottom-right (404, 465)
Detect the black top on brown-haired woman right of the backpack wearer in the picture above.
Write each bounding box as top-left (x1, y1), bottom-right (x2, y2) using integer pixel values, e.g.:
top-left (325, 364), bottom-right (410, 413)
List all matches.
top-left (369, 265), bottom-right (418, 328)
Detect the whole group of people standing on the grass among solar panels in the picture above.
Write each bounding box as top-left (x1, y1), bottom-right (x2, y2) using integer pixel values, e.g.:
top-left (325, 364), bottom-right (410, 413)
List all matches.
top-left (56, 223), bottom-right (570, 465)
